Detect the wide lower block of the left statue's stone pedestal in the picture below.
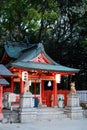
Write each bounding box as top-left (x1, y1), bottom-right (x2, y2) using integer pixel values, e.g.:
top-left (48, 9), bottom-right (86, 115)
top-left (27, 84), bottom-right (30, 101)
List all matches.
top-left (19, 108), bottom-right (37, 123)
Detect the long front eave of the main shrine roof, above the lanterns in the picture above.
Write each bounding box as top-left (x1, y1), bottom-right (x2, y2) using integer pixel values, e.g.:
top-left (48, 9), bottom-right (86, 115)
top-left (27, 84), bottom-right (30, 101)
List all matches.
top-left (12, 62), bottom-right (79, 73)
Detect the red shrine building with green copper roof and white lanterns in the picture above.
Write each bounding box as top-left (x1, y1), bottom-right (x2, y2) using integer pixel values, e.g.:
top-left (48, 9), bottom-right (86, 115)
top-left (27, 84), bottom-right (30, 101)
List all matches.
top-left (1, 42), bottom-right (79, 111)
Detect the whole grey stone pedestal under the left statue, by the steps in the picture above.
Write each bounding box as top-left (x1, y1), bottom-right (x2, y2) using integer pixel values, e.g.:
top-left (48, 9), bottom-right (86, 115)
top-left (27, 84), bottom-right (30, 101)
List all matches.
top-left (19, 92), bottom-right (36, 122)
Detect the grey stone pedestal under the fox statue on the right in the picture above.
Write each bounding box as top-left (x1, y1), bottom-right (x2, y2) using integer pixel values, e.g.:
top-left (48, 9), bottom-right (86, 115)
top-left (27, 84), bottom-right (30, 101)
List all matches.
top-left (64, 94), bottom-right (83, 119)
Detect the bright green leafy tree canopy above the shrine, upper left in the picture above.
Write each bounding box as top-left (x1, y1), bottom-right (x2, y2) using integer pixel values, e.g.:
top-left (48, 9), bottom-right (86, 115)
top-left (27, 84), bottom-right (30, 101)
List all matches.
top-left (0, 0), bottom-right (58, 42)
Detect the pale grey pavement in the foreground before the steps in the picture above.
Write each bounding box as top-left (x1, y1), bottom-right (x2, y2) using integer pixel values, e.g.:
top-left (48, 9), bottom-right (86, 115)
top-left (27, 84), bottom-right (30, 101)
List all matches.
top-left (0, 118), bottom-right (87, 130)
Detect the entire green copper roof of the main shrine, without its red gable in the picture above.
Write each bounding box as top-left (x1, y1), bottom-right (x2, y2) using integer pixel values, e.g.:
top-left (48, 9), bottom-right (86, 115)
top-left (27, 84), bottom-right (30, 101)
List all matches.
top-left (5, 43), bottom-right (79, 72)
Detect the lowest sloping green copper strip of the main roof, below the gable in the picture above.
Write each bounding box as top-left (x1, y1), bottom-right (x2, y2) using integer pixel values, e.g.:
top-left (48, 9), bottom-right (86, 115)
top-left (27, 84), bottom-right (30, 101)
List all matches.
top-left (12, 61), bottom-right (79, 73)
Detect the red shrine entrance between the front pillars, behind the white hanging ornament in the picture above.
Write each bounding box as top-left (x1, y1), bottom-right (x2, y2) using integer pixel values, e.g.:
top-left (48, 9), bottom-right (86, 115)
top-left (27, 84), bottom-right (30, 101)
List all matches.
top-left (29, 80), bottom-right (53, 107)
